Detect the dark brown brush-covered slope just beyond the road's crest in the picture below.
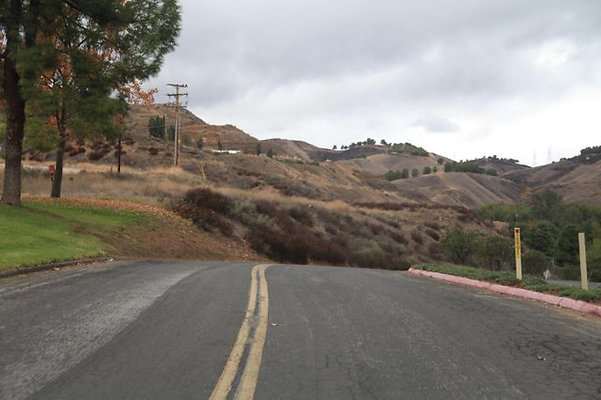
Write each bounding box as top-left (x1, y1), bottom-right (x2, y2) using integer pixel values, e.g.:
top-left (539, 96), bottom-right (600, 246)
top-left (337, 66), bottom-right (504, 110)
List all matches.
top-left (174, 188), bottom-right (490, 269)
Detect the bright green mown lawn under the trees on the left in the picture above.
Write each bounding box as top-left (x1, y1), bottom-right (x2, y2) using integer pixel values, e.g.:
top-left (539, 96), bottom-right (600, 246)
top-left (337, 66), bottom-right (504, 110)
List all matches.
top-left (0, 202), bottom-right (143, 270)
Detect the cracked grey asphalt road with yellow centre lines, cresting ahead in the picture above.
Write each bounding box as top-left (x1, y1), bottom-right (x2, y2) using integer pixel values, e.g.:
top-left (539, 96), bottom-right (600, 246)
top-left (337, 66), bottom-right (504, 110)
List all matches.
top-left (0, 262), bottom-right (601, 400)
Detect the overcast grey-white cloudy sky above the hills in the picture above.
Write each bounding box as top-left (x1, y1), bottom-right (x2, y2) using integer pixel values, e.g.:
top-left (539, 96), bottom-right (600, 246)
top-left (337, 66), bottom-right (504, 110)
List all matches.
top-left (148, 0), bottom-right (601, 165)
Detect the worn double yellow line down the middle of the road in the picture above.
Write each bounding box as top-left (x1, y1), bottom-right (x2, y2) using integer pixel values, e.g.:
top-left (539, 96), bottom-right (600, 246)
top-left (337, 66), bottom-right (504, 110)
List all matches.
top-left (210, 264), bottom-right (269, 400)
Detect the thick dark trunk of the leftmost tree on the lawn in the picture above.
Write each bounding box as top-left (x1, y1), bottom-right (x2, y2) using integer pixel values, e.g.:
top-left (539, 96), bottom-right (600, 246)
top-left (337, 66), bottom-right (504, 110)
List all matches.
top-left (1, 0), bottom-right (25, 206)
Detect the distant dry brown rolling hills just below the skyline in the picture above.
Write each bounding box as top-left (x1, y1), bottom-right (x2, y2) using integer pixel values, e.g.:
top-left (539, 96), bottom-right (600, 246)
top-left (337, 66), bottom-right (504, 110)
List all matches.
top-left (17, 105), bottom-right (601, 208)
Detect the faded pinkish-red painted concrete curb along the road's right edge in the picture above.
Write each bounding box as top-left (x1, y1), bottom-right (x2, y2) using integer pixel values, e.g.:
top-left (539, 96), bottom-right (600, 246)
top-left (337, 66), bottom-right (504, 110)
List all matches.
top-left (407, 268), bottom-right (601, 317)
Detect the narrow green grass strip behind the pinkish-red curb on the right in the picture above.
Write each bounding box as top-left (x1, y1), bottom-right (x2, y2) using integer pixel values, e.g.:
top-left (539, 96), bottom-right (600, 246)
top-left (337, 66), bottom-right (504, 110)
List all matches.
top-left (413, 263), bottom-right (601, 302)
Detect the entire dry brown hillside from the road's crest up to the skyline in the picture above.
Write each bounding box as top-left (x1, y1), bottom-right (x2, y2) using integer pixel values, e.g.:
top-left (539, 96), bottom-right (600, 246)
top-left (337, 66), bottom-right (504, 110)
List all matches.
top-left (1, 105), bottom-right (601, 273)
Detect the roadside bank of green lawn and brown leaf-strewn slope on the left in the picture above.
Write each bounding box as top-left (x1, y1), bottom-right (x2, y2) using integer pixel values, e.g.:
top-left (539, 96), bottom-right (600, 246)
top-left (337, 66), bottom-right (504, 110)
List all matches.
top-left (0, 196), bottom-right (264, 271)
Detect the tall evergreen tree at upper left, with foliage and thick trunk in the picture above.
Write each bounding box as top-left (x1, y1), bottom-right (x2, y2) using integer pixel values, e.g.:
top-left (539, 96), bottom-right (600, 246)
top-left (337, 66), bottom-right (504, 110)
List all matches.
top-left (0, 0), bottom-right (180, 205)
